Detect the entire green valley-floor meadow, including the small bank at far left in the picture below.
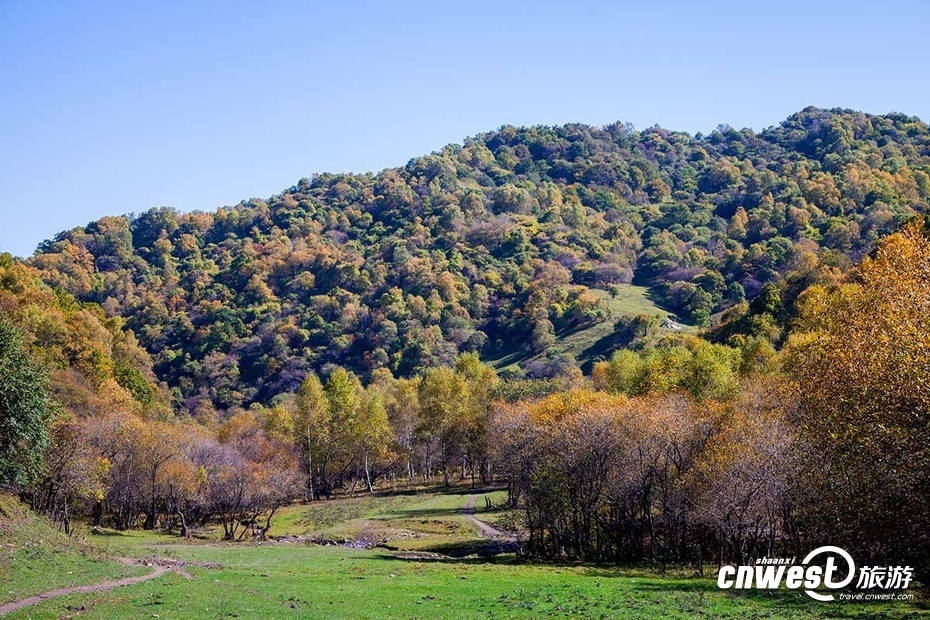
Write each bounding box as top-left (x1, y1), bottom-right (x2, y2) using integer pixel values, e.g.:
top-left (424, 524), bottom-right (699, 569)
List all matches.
top-left (0, 488), bottom-right (930, 620)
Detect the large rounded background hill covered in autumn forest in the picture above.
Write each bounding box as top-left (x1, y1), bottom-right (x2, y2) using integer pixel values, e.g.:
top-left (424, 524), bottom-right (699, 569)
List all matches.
top-left (29, 108), bottom-right (930, 410)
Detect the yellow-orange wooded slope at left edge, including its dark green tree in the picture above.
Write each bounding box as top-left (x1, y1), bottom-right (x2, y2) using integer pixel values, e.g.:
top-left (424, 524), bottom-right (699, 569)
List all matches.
top-left (0, 254), bottom-right (166, 490)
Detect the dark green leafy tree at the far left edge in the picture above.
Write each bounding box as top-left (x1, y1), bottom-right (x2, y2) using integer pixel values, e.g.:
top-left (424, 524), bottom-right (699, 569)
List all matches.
top-left (0, 317), bottom-right (54, 484)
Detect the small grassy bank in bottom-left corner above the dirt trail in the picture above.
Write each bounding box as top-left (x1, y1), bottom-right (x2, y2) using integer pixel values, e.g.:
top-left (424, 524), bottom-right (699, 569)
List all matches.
top-left (0, 494), bottom-right (146, 603)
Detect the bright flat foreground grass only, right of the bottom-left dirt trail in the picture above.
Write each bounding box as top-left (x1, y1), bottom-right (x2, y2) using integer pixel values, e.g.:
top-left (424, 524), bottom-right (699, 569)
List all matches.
top-left (10, 544), bottom-right (926, 620)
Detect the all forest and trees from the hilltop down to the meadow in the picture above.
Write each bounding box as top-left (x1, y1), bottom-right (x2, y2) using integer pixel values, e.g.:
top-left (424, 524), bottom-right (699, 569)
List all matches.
top-left (0, 108), bottom-right (930, 578)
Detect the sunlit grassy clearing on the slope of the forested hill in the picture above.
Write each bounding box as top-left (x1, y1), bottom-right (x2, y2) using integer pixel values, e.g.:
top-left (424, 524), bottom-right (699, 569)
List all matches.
top-left (485, 284), bottom-right (697, 372)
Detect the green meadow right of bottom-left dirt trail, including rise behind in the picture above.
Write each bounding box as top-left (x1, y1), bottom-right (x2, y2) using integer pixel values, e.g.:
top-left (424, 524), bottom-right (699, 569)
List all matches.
top-left (3, 488), bottom-right (930, 620)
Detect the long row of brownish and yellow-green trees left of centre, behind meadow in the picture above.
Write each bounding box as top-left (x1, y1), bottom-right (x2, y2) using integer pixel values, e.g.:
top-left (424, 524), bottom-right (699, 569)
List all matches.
top-left (12, 354), bottom-right (497, 539)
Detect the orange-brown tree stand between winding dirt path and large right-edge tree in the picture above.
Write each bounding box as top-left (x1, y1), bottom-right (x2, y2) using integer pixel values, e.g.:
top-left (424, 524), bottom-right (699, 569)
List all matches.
top-left (498, 386), bottom-right (792, 565)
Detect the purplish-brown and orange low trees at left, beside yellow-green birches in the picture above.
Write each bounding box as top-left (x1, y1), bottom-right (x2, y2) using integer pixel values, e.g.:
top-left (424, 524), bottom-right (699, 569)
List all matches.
top-left (27, 412), bottom-right (300, 540)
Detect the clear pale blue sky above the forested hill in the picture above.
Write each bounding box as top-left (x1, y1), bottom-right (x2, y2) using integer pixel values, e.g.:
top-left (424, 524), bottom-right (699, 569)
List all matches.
top-left (0, 0), bottom-right (930, 256)
